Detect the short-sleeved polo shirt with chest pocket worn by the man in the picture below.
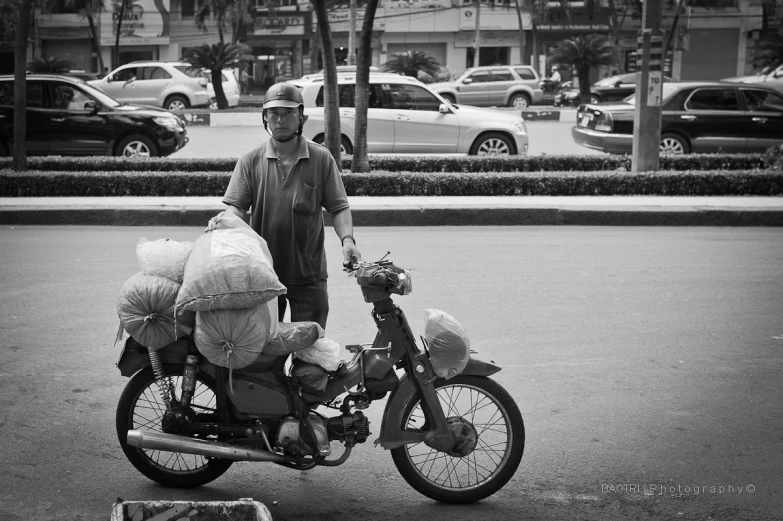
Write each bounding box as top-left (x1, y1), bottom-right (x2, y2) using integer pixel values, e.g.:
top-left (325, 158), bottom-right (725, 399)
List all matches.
top-left (223, 136), bottom-right (349, 285)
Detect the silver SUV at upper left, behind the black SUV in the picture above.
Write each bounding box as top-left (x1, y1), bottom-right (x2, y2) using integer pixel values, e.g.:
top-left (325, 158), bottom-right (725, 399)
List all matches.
top-left (87, 61), bottom-right (209, 111)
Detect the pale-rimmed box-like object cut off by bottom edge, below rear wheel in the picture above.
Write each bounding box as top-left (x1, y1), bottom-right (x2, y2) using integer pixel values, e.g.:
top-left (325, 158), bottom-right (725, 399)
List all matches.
top-left (111, 499), bottom-right (272, 521)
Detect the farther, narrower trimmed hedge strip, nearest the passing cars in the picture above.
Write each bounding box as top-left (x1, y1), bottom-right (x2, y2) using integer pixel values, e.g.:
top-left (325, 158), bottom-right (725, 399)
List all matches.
top-left (0, 154), bottom-right (774, 173)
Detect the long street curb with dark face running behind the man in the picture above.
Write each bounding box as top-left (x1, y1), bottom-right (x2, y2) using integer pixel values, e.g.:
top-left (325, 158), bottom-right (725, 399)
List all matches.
top-left (0, 206), bottom-right (783, 227)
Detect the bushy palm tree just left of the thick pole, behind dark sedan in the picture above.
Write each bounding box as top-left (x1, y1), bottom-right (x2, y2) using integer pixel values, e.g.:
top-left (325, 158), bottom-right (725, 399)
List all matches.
top-left (549, 34), bottom-right (617, 103)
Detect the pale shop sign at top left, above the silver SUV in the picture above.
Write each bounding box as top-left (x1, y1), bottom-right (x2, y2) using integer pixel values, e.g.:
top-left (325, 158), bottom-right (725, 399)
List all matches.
top-left (101, 0), bottom-right (171, 45)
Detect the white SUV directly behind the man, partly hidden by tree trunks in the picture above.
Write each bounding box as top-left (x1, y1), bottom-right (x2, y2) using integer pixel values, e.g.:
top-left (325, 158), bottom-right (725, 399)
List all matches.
top-left (300, 73), bottom-right (528, 155)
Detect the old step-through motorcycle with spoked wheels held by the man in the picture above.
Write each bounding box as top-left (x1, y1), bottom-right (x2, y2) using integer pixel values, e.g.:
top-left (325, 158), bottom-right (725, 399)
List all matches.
top-left (116, 254), bottom-right (525, 503)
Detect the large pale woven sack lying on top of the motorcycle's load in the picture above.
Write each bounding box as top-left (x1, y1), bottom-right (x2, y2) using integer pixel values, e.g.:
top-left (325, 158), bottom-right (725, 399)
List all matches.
top-left (177, 213), bottom-right (286, 311)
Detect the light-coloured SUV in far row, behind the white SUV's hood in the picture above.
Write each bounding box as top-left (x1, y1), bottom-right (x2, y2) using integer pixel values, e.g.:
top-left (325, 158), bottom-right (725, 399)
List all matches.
top-left (429, 65), bottom-right (544, 109)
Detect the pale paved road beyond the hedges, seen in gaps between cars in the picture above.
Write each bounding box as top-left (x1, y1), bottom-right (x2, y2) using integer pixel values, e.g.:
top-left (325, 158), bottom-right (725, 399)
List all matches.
top-left (172, 121), bottom-right (603, 158)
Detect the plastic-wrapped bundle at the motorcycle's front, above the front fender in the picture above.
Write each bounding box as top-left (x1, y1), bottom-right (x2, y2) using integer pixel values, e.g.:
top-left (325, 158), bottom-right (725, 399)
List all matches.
top-left (424, 309), bottom-right (470, 380)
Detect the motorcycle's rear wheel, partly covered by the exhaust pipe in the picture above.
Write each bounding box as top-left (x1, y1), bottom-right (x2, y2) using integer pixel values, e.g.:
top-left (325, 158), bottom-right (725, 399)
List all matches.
top-left (116, 364), bottom-right (234, 488)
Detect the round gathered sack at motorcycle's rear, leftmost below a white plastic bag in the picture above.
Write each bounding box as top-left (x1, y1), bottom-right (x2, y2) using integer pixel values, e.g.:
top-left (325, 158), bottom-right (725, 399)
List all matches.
top-left (117, 272), bottom-right (196, 349)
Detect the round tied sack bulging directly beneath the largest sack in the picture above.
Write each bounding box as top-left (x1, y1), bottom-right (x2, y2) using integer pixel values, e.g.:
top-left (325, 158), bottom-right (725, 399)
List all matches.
top-left (193, 299), bottom-right (278, 369)
